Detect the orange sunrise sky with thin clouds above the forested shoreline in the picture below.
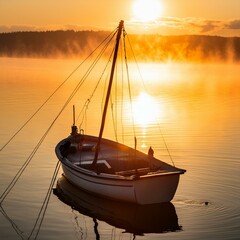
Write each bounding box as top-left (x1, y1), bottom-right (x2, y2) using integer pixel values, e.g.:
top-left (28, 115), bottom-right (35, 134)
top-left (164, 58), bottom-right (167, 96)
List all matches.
top-left (0, 0), bottom-right (240, 36)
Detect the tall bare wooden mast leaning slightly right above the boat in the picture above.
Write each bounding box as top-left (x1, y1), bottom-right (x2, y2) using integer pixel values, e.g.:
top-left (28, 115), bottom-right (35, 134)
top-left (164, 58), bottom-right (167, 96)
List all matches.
top-left (92, 21), bottom-right (124, 169)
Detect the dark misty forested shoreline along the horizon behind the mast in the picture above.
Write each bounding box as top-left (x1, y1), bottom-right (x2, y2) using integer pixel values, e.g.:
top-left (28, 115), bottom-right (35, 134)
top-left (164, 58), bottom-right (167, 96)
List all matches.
top-left (0, 30), bottom-right (240, 61)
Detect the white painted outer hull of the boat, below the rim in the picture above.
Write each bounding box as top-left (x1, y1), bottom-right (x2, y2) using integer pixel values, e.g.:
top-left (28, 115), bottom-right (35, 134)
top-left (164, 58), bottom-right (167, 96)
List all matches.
top-left (56, 135), bottom-right (183, 204)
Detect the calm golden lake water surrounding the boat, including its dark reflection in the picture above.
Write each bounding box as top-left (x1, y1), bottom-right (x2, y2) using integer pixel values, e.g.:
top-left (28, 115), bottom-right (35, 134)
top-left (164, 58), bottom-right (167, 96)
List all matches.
top-left (0, 58), bottom-right (240, 240)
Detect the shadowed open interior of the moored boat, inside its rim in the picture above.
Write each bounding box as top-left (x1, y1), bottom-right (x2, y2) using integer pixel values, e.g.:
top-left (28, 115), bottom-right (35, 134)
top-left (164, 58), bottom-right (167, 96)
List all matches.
top-left (58, 134), bottom-right (176, 176)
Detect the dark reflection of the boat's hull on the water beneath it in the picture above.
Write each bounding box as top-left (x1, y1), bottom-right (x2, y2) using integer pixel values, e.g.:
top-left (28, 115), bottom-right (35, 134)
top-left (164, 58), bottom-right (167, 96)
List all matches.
top-left (54, 176), bottom-right (181, 235)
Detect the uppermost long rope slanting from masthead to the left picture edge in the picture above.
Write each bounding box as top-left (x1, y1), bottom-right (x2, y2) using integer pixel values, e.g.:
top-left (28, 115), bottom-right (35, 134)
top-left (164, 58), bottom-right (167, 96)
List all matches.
top-left (0, 30), bottom-right (116, 152)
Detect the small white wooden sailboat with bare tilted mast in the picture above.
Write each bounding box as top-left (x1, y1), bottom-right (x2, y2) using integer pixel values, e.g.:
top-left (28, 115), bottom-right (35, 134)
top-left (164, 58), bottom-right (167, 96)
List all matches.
top-left (56, 21), bottom-right (185, 204)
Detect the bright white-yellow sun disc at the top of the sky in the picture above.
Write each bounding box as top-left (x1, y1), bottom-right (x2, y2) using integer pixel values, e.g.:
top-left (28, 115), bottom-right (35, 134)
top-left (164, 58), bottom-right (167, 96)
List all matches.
top-left (133, 0), bottom-right (163, 22)
